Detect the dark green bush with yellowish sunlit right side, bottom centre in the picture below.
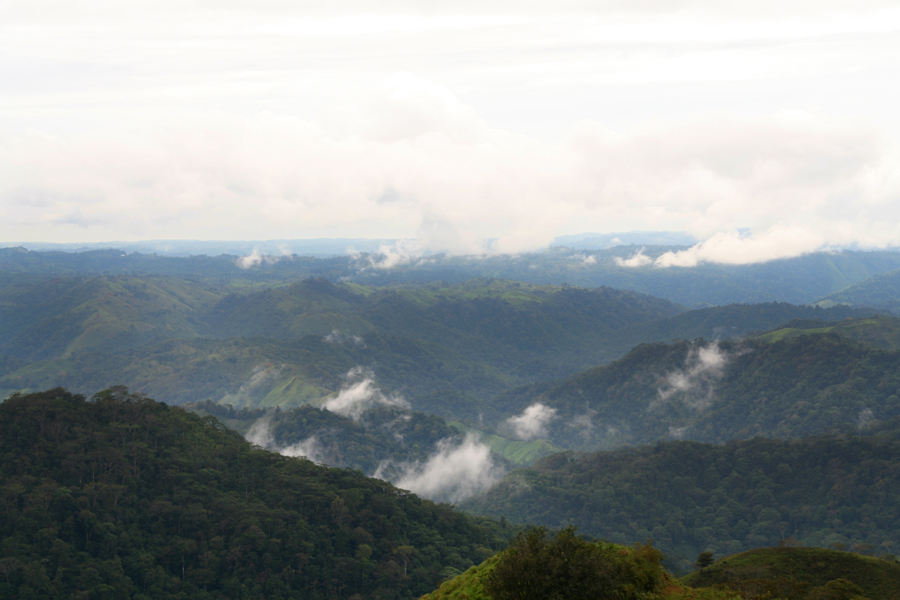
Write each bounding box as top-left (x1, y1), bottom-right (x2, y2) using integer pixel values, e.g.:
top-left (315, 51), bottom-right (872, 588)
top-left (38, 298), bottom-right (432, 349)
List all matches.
top-left (483, 527), bottom-right (665, 600)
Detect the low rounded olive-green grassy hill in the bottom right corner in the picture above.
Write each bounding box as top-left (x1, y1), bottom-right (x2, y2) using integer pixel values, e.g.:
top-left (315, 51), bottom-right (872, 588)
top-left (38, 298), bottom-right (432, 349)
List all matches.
top-left (681, 547), bottom-right (900, 600)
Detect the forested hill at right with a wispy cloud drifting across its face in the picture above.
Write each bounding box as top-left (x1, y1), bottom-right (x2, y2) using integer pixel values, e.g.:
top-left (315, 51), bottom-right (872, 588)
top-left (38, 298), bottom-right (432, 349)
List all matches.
top-left (495, 333), bottom-right (900, 450)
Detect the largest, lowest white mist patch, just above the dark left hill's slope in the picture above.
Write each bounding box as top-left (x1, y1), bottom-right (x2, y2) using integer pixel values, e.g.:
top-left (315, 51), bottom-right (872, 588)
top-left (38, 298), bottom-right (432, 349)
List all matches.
top-left (388, 435), bottom-right (502, 502)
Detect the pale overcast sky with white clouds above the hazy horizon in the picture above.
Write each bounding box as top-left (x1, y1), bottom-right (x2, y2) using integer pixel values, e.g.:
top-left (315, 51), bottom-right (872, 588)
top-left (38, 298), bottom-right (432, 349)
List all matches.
top-left (0, 0), bottom-right (900, 266)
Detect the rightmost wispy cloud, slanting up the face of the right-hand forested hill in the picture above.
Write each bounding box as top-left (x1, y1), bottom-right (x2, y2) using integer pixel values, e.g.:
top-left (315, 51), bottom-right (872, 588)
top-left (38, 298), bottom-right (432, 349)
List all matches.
top-left (657, 342), bottom-right (729, 410)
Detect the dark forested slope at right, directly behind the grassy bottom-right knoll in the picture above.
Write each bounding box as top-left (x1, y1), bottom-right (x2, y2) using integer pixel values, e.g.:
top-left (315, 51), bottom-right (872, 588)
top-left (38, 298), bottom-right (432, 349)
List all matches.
top-left (462, 421), bottom-right (900, 569)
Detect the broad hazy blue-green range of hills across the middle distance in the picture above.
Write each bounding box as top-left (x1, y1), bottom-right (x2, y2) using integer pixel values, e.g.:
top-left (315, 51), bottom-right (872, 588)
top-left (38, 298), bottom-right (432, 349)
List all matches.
top-left (0, 276), bottom-right (868, 410)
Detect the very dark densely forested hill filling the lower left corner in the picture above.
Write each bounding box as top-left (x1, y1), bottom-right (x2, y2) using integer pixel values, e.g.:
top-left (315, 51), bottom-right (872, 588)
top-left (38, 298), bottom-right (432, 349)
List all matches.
top-left (0, 389), bottom-right (510, 599)
